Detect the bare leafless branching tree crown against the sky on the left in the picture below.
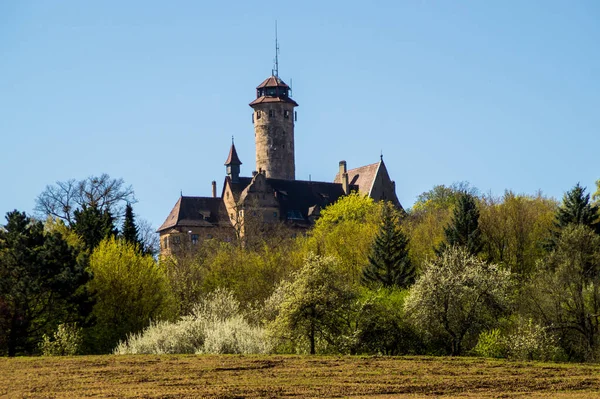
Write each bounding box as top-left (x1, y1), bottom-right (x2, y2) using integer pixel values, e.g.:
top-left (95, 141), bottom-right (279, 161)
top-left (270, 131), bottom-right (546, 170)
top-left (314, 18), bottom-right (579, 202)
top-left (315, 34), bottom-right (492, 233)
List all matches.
top-left (35, 173), bottom-right (135, 226)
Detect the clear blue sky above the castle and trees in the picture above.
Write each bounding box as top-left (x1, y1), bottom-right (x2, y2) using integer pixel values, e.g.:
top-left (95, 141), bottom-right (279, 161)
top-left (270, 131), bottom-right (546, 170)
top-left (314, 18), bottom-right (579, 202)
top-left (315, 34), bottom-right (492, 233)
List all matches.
top-left (0, 0), bottom-right (600, 231)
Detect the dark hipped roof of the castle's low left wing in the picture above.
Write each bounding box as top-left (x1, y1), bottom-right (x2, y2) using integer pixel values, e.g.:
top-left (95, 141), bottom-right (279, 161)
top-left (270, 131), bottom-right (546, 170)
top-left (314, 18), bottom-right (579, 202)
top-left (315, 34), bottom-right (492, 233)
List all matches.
top-left (157, 196), bottom-right (229, 232)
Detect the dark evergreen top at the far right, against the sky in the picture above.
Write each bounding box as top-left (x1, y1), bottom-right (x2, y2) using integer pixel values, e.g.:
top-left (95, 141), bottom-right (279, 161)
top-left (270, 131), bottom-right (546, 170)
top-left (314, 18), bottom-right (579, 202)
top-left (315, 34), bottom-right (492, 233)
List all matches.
top-left (555, 183), bottom-right (600, 233)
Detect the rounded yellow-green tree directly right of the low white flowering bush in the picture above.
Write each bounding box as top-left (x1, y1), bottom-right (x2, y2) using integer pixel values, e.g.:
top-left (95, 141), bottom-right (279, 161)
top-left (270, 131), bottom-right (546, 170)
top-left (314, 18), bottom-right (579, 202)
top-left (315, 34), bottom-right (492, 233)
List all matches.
top-left (269, 254), bottom-right (357, 354)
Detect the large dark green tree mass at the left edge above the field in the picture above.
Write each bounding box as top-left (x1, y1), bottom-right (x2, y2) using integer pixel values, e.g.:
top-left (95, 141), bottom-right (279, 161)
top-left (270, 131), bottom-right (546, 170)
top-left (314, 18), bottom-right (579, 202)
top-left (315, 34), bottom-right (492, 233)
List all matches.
top-left (0, 211), bottom-right (91, 356)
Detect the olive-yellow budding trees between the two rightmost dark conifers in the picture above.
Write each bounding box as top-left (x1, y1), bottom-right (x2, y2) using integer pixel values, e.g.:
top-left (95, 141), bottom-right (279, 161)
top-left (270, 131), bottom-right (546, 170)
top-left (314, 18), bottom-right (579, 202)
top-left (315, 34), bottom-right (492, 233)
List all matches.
top-left (479, 191), bottom-right (557, 276)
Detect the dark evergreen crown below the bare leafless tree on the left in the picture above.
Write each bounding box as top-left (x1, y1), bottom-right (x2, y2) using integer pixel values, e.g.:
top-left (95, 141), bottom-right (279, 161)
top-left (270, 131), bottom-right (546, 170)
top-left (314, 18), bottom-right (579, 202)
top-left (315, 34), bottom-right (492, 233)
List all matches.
top-left (73, 205), bottom-right (117, 252)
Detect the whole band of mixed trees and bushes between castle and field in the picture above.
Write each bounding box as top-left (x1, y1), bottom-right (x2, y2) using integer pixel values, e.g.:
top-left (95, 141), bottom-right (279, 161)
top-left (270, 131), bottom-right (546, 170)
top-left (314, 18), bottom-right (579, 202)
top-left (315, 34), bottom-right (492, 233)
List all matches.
top-left (0, 177), bottom-right (600, 361)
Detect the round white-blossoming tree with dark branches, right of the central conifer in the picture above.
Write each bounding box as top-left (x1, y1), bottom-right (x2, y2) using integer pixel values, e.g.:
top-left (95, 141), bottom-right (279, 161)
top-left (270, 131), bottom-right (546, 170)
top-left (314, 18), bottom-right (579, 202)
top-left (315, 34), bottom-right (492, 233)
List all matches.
top-left (405, 246), bottom-right (511, 355)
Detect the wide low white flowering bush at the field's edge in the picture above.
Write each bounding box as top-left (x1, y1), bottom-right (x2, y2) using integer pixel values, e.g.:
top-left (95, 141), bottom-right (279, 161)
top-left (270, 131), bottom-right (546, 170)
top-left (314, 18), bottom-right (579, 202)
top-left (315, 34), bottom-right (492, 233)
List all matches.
top-left (114, 290), bottom-right (270, 354)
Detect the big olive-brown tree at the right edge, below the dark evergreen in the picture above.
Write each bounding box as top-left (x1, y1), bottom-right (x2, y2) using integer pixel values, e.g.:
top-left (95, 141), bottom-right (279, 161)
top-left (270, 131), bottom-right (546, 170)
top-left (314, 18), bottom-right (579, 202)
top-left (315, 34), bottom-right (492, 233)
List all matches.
top-left (527, 223), bottom-right (600, 361)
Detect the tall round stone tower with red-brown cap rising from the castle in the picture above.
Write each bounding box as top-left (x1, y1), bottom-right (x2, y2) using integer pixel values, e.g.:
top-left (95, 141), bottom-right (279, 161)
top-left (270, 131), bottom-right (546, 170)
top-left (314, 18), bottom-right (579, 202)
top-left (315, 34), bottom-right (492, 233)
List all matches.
top-left (250, 73), bottom-right (298, 180)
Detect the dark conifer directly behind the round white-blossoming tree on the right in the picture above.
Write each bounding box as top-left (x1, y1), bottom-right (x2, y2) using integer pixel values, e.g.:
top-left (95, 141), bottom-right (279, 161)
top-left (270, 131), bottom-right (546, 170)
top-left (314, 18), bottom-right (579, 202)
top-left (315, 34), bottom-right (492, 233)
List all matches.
top-left (437, 192), bottom-right (483, 255)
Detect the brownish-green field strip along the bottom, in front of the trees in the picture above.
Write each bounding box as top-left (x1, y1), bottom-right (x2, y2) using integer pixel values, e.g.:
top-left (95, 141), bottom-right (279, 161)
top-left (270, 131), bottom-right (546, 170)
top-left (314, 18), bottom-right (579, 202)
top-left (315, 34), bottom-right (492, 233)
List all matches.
top-left (0, 355), bottom-right (600, 398)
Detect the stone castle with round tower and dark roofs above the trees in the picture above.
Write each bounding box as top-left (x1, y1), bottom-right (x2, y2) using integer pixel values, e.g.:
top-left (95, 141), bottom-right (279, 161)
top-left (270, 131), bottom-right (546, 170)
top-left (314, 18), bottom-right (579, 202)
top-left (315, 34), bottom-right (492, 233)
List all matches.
top-left (157, 69), bottom-right (401, 255)
